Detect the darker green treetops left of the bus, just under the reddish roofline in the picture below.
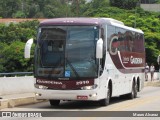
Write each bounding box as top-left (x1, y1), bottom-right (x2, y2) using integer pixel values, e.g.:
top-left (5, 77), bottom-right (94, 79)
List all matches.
top-left (0, 20), bottom-right (39, 44)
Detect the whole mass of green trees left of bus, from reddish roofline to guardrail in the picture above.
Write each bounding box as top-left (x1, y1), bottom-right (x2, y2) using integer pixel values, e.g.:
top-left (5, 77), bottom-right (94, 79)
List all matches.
top-left (0, 21), bottom-right (39, 72)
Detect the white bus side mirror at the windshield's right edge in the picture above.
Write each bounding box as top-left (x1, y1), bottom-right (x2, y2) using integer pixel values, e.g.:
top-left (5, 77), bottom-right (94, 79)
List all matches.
top-left (96, 38), bottom-right (103, 59)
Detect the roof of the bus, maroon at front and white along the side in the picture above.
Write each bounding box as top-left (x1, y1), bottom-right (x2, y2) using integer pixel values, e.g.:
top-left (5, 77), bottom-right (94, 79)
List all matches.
top-left (40, 17), bottom-right (143, 34)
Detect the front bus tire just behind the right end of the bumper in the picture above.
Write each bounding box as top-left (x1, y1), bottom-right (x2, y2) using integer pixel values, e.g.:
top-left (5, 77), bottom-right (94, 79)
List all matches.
top-left (99, 87), bottom-right (111, 106)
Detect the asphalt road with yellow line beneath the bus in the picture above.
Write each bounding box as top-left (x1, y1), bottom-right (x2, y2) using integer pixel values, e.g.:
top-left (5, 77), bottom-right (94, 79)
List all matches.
top-left (3, 86), bottom-right (160, 120)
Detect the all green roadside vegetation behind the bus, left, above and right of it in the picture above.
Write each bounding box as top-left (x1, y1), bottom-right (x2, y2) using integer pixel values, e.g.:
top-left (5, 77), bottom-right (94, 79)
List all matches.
top-left (0, 0), bottom-right (160, 72)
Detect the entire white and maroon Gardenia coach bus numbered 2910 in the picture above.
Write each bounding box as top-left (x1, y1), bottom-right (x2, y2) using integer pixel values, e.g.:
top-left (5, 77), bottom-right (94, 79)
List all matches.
top-left (24, 18), bottom-right (145, 106)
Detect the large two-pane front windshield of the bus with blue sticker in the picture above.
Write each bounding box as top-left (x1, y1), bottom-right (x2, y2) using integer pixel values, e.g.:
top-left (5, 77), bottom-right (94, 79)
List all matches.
top-left (35, 26), bottom-right (99, 78)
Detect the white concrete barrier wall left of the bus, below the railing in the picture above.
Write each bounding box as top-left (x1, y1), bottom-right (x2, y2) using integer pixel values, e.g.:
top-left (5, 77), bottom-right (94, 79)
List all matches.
top-left (0, 76), bottom-right (35, 96)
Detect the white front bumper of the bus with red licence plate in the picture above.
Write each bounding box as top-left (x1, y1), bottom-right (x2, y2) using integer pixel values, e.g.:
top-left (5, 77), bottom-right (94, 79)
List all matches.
top-left (36, 88), bottom-right (100, 101)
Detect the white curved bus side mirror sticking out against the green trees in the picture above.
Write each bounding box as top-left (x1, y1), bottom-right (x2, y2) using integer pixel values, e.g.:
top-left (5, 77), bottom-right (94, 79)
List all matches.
top-left (24, 38), bottom-right (33, 58)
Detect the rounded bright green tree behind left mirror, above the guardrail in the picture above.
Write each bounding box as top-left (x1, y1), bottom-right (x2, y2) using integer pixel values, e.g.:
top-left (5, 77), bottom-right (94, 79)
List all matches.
top-left (1, 41), bottom-right (33, 72)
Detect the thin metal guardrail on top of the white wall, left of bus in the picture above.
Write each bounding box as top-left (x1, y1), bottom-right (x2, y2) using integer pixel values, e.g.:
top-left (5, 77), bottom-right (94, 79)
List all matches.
top-left (0, 72), bottom-right (33, 77)
